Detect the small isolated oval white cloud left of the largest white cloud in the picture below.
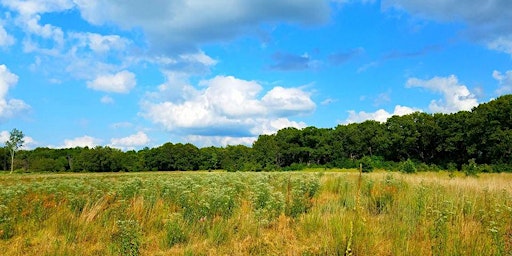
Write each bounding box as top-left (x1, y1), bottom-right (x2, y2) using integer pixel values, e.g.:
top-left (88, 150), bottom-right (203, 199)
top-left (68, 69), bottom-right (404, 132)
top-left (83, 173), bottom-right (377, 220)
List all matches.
top-left (87, 70), bottom-right (136, 93)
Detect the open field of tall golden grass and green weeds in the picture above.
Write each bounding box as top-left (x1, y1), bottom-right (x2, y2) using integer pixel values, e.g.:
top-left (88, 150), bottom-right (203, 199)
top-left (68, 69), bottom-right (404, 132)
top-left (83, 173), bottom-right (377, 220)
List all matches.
top-left (0, 171), bottom-right (512, 255)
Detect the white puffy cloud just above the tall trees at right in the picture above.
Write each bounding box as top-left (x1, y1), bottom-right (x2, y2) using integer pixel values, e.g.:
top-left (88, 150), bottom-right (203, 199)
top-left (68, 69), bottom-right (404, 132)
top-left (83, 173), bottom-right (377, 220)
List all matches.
top-left (406, 75), bottom-right (478, 113)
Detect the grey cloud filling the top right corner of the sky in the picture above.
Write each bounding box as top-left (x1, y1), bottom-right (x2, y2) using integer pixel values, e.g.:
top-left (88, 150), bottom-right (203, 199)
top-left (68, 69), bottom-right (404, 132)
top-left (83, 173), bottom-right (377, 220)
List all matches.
top-left (382, 0), bottom-right (512, 54)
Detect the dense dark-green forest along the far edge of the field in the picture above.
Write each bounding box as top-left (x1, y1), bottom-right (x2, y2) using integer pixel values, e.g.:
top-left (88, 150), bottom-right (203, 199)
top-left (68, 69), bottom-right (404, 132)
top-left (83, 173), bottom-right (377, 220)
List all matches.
top-left (0, 95), bottom-right (512, 172)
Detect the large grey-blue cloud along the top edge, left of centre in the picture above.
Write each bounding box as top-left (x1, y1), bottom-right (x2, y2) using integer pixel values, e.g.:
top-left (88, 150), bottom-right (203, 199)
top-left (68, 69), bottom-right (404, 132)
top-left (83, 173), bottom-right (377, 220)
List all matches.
top-left (74, 0), bottom-right (329, 53)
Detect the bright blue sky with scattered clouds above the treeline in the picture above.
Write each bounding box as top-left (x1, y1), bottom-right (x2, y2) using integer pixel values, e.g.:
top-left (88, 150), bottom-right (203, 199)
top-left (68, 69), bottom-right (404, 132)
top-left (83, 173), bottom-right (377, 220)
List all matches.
top-left (0, 0), bottom-right (512, 150)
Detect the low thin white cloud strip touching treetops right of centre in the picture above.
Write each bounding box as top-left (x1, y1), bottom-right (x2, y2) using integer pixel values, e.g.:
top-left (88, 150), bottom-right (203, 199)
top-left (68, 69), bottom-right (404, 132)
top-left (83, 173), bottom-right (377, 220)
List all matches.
top-left (343, 105), bottom-right (421, 124)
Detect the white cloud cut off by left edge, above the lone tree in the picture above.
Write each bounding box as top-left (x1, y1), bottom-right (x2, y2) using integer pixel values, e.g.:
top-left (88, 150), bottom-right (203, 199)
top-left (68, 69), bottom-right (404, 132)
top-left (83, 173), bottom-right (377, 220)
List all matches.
top-left (0, 65), bottom-right (30, 121)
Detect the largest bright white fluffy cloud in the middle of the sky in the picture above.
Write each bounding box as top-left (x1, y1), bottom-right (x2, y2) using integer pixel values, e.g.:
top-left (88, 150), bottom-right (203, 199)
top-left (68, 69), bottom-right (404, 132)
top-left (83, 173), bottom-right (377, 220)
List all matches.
top-left (141, 76), bottom-right (316, 142)
